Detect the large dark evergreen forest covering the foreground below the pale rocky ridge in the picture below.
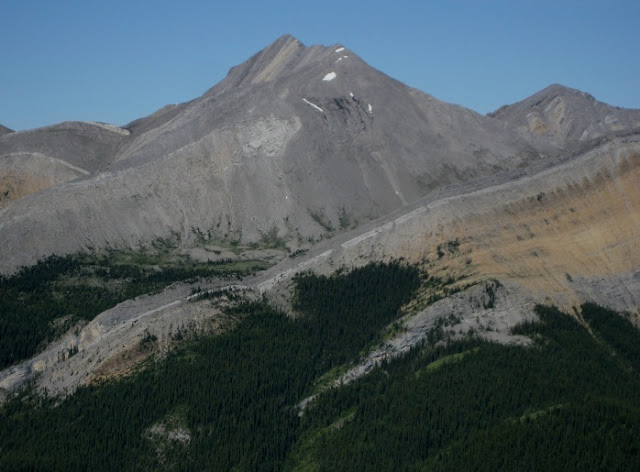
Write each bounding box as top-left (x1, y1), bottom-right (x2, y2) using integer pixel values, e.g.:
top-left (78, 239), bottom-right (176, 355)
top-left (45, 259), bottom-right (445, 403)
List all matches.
top-left (0, 263), bottom-right (640, 471)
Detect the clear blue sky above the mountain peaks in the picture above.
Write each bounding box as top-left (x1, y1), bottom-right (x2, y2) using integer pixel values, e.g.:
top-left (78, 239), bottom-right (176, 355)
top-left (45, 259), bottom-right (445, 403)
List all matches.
top-left (0, 0), bottom-right (640, 130)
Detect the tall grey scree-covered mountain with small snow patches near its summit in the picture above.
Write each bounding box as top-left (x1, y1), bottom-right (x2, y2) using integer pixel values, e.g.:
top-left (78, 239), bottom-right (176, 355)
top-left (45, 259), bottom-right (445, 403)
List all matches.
top-left (0, 36), bottom-right (559, 272)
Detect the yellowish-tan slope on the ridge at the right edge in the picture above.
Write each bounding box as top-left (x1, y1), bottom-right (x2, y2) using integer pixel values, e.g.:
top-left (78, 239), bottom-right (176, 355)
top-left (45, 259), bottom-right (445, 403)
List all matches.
top-left (425, 146), bottom-right (640, 310)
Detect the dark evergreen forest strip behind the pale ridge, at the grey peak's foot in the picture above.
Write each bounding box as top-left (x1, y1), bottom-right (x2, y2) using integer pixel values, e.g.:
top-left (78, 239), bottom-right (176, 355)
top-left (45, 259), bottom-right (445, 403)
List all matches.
top-left (0, 255), bottom-right (266, 369)
